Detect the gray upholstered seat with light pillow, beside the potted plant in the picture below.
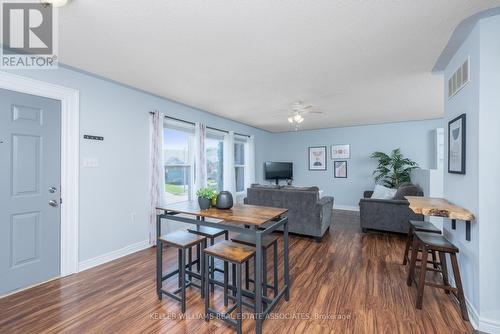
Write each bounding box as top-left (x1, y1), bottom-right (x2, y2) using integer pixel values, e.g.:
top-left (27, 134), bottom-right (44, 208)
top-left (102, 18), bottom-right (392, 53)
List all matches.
top-left (359, 183), bottom-right (424, 233)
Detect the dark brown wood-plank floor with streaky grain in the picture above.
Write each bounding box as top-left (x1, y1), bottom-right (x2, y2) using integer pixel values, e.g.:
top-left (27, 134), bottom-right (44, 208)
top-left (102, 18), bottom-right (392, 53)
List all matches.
top-left (0, 211), bottom-right (473, 334)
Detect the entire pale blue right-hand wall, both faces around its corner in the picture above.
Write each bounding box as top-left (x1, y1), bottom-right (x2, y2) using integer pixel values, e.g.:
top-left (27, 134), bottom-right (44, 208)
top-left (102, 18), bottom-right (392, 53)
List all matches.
top-left (443, 15), bottom-right (500, 333)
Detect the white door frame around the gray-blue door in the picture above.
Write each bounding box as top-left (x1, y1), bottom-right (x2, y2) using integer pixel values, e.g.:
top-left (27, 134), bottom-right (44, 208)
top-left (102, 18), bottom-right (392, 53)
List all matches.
top-left (0, 70), bottom-right (80, 277)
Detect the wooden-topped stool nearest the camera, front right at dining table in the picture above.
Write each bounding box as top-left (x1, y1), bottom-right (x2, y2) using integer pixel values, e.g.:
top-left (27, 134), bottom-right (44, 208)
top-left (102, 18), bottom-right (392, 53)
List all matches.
top-left (203, 240), bottom-right (255, 334)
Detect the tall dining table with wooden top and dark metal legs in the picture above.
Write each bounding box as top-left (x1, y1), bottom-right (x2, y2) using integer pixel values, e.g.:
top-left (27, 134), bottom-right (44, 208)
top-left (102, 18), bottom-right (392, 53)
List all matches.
top-left (156, 201), bottom-right (290, 334)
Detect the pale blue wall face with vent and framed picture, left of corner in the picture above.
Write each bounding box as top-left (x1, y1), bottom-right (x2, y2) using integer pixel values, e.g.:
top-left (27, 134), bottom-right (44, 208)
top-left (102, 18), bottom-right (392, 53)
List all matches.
top-left (443, 20), bottom-right (479, 324)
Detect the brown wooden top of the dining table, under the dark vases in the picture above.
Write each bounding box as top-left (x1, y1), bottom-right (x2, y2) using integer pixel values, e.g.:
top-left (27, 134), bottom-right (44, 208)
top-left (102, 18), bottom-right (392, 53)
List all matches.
top-left (156, 201), bottom-right (288, 226)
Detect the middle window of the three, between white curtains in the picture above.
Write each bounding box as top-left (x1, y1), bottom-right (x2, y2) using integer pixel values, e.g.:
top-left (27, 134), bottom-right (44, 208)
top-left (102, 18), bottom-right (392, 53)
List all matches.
top-left (205, 131), bottom-right (224, 191)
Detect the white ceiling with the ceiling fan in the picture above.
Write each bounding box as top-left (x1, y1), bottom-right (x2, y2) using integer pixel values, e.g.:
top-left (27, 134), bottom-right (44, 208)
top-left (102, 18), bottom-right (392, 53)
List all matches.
top-left (59, 0), bottom-right (500, 131)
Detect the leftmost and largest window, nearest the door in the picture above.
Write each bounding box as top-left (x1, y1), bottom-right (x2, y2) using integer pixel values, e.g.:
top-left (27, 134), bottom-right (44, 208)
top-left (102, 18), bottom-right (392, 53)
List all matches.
top-left (163, 122), bottom-right (194, 203)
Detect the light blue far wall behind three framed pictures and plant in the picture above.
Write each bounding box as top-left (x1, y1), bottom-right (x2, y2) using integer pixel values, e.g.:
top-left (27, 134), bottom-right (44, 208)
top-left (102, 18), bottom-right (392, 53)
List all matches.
top-left (268, 119), bottom-right (442, 209)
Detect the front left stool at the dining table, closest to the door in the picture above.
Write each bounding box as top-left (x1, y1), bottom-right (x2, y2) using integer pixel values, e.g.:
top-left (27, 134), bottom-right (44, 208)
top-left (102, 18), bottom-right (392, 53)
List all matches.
top-left (156, 231), bottom-right (207, 313)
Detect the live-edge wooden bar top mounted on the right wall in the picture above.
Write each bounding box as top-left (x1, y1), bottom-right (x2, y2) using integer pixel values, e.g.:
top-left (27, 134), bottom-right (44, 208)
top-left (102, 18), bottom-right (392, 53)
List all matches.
top-left (405, 196), bottom-right (474, 221)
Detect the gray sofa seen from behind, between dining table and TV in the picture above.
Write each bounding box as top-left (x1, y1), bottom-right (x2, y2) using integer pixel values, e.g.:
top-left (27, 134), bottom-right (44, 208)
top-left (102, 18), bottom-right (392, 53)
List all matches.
top-left (245, 184), bottom-right (333, 242)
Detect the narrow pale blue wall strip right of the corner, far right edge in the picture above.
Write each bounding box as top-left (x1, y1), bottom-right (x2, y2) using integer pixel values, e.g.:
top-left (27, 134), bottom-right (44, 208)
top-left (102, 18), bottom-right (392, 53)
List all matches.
top-left (478, 15), bottom-right (500, 326)
